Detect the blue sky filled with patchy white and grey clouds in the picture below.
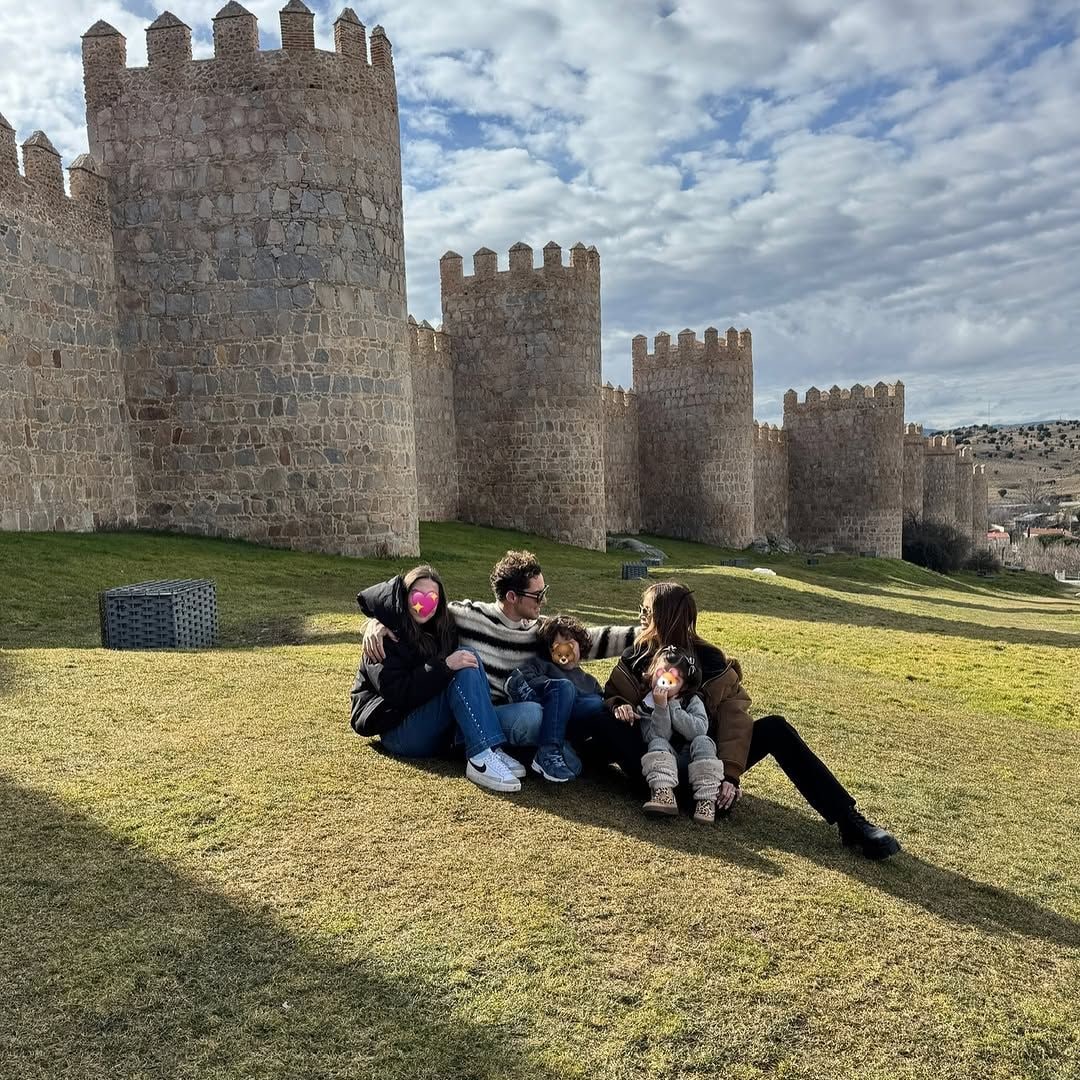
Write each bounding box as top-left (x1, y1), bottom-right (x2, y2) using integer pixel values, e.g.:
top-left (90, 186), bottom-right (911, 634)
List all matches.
top-left (0, 0), bottom-right (1080, 427)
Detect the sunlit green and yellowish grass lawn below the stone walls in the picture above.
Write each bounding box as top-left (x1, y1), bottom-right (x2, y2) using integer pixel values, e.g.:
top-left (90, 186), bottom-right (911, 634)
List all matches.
top-left (0, 525), bottom-right (1080, 1080)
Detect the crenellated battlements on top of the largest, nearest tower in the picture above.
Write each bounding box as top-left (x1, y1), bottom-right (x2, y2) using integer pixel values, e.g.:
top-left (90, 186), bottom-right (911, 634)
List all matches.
top-left (82, 0), bottom-right (396, 116)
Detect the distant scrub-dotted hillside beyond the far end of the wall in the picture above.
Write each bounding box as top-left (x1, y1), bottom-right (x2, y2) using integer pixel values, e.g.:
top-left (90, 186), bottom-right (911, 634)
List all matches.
top-left (946, 420), bottom-right (1080, 507)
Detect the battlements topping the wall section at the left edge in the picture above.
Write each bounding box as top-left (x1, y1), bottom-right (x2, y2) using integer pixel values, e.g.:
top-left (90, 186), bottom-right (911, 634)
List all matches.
top-left (0, 121), bottom-right (111, 240)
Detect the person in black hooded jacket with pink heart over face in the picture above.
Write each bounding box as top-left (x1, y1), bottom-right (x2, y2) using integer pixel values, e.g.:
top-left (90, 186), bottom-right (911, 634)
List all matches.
top-left (353, 566), bottom-right (525, 792)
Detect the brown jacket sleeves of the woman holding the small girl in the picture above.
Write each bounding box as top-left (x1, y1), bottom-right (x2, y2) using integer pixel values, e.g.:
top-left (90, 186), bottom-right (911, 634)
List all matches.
top-left (604, 644), bottom-right (754, 783)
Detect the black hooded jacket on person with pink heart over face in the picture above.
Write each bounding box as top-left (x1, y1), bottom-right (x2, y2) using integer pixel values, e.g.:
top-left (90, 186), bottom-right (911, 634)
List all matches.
top-left (350, 576), bottom-right (454, 735)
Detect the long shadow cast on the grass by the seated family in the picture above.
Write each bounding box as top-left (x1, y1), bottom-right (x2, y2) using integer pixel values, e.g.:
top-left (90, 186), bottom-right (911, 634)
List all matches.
top-left (373, 744), bottom-right (1080, 948)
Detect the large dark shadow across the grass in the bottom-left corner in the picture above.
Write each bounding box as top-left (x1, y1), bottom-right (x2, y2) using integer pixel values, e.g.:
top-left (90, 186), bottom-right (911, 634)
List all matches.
top-left (0, 779), bottom-right (545, 1080)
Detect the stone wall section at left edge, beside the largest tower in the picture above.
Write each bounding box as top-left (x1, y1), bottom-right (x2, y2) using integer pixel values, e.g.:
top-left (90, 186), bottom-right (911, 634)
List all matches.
top-left (0, 117), bottom-right (135, 530)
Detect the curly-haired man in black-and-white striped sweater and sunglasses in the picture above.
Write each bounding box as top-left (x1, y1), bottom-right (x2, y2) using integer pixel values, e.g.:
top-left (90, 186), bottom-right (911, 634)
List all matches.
top-left (364, 551), bottom-right (642, 780)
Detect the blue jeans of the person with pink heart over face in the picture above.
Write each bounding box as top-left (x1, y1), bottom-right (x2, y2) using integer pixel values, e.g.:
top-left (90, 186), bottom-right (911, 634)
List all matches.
top-left (382, 648), bottom-right (511, 757)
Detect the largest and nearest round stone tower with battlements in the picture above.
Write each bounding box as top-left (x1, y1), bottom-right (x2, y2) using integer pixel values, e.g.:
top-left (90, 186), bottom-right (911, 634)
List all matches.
top-left (83, 0), bottom-right (419, 554)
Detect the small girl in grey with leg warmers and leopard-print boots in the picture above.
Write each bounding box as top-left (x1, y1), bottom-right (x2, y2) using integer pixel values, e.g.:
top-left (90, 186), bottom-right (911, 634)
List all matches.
top-left (637, 646), bottom-right (724, 822)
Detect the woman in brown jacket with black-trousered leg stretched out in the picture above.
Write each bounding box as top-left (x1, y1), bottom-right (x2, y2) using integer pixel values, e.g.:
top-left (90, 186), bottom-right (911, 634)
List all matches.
top-left (604, 581), bottom-right (900, 859)
